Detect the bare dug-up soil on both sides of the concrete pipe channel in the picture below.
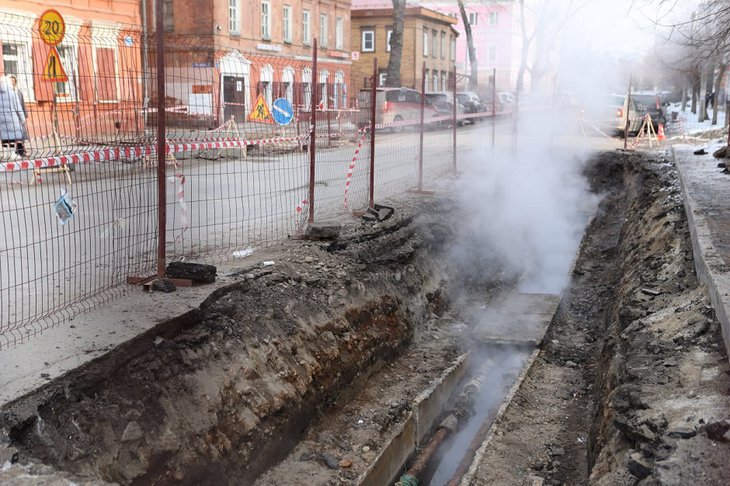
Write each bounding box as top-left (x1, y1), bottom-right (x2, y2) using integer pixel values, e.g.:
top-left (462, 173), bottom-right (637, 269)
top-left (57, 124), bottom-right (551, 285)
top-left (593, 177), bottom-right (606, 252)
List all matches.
top-left (0, 148), bottom-right (730, 485)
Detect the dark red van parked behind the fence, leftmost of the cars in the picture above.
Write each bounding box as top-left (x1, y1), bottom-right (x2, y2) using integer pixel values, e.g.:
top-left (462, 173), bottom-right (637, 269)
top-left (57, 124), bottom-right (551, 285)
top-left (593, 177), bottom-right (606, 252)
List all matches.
top-left (358, 88), bottom-right (441, 132)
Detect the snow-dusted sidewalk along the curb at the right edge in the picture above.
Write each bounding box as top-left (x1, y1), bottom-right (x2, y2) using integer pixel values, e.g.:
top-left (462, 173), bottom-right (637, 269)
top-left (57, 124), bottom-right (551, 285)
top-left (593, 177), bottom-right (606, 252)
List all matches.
top-left (672, 142), bottom-right (730, 354)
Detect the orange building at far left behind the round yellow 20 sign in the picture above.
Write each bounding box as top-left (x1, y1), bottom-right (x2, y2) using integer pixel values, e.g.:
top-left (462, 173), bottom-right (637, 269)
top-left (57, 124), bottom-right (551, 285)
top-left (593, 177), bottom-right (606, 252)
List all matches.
top-left (0, 0), bottom-right (142, 143)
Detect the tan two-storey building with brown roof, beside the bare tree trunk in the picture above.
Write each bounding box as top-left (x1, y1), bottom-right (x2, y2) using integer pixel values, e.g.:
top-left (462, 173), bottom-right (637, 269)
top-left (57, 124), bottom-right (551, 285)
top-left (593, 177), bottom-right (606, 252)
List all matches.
top-left (350, 7), bottom-right (458, 92)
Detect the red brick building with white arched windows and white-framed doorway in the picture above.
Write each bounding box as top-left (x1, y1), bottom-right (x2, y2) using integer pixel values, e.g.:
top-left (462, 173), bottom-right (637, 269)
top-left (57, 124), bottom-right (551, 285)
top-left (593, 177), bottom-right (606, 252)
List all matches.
top-left (148, 0), bottom-right (351, 123)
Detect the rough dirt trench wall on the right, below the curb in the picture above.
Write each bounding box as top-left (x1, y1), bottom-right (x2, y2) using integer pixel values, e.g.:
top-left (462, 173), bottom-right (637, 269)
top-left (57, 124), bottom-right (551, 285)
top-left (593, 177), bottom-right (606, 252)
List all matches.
top-left (588, 156), bottom-right (727, 485)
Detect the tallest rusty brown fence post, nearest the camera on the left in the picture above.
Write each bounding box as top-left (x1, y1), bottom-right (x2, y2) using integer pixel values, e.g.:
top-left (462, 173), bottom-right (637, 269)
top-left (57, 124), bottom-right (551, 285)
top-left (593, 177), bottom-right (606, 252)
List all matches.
top-left (155, 0), bottom-right (167, 278)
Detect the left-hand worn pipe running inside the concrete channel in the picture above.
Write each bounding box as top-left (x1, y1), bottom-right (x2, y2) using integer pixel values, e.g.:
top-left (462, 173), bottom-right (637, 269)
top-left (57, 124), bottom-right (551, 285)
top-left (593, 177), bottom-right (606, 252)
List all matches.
top-left (395, 359), bottom-right (494, 486)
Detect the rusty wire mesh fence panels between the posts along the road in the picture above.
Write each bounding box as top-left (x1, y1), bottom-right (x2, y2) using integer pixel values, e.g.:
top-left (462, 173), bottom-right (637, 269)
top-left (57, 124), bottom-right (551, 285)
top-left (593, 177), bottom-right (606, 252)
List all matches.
top-left (0, 10), bottom-right (492, 349)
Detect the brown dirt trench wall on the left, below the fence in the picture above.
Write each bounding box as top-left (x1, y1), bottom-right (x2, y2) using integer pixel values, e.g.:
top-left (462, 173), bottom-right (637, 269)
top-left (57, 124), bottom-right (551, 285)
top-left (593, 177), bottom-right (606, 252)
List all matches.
top-left (1, 211), bottom-right (456, 484)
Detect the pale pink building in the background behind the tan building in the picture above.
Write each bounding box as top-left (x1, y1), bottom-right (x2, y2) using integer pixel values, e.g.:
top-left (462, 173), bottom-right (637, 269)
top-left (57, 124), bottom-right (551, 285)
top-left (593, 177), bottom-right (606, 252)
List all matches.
top-left (352, 0), bottom-right (529, 96)
